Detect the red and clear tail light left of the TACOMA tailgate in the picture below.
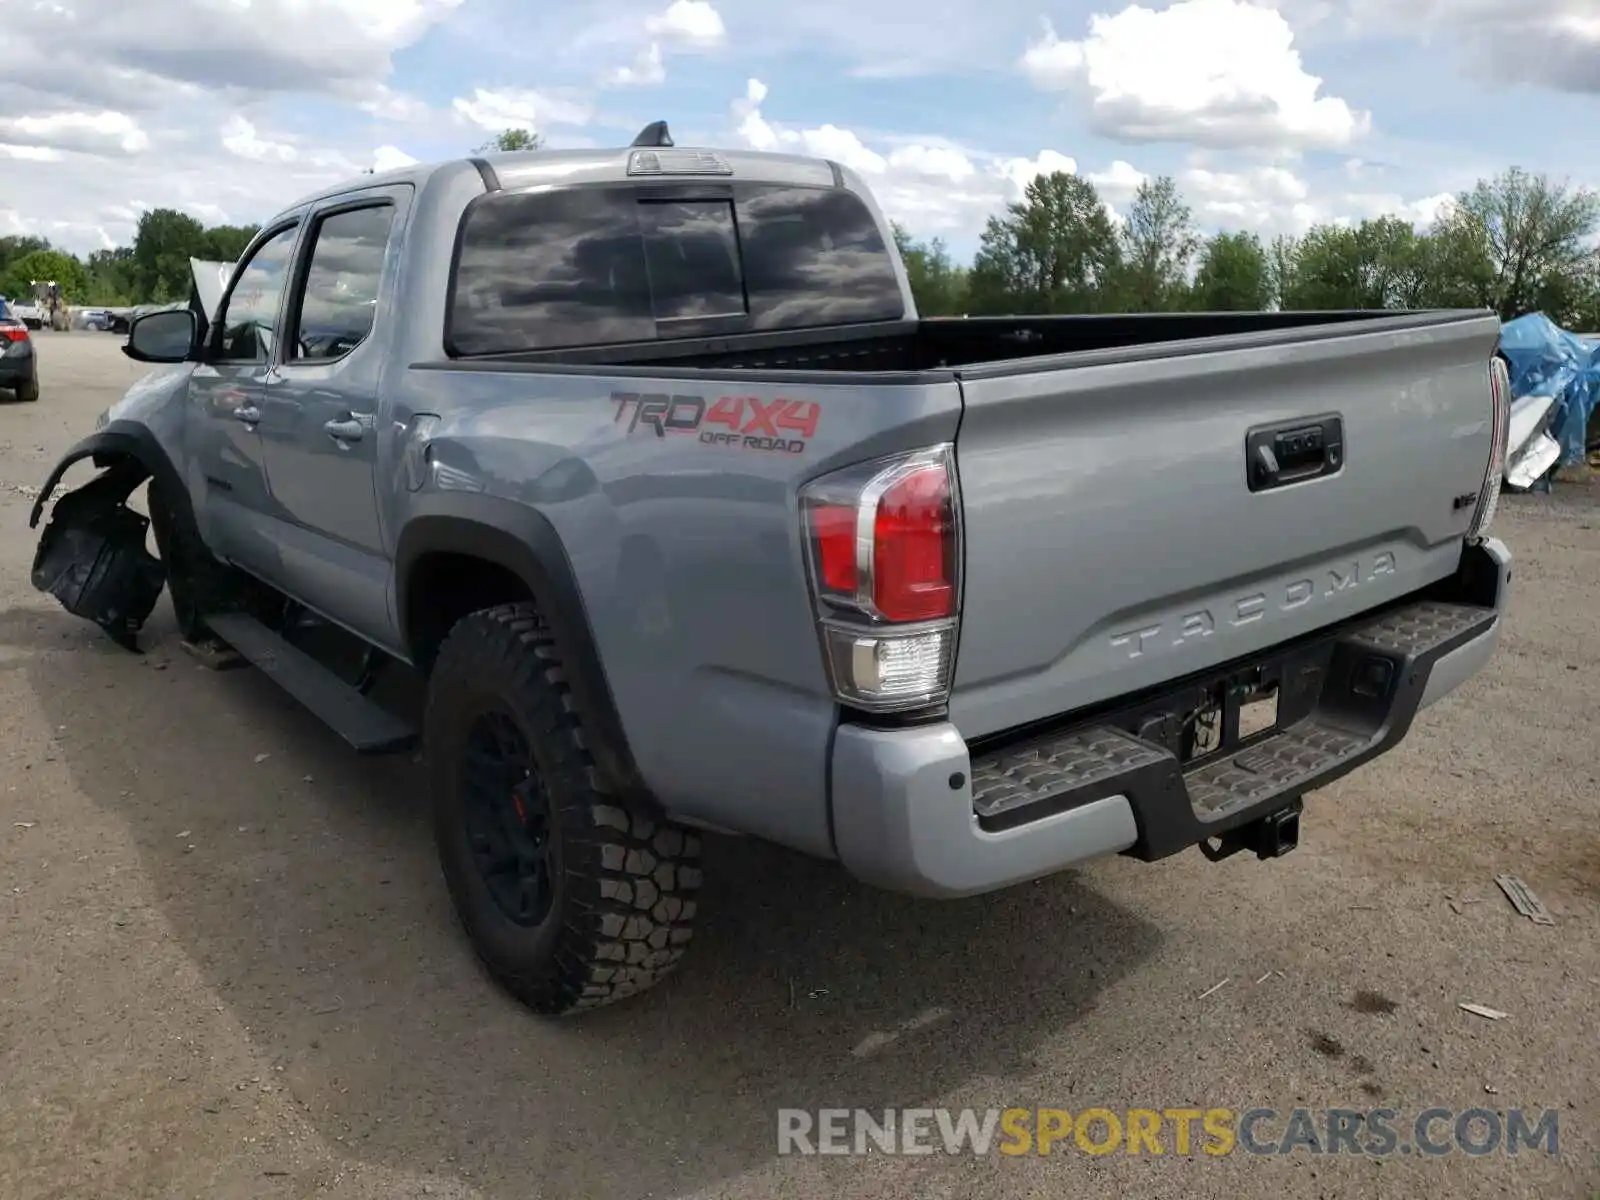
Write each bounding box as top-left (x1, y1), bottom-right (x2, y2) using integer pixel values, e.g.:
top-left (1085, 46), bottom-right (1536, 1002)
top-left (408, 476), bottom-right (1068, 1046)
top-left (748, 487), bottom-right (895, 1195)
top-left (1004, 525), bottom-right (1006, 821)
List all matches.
top-left (800, 445), bottom-right (962, 712)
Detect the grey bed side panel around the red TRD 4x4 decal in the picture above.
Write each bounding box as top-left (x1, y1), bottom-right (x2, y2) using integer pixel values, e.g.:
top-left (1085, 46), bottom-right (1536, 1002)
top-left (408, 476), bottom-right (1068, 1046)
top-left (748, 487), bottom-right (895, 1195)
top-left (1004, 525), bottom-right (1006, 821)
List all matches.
top-left (389, 370), bottom-right (960, 854)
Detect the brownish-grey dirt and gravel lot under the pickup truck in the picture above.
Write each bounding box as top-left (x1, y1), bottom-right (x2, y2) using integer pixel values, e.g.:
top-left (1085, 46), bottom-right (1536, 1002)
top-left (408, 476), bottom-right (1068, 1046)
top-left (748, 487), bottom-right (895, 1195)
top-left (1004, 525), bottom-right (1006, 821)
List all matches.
top-left (0, 333), bottom-right (1600, 1200)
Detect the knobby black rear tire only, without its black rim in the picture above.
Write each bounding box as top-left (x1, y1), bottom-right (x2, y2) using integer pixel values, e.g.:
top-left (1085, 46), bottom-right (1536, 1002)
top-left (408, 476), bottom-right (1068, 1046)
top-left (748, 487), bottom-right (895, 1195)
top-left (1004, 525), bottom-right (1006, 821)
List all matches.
top-left (424, 603), bottom-right (701, 1016)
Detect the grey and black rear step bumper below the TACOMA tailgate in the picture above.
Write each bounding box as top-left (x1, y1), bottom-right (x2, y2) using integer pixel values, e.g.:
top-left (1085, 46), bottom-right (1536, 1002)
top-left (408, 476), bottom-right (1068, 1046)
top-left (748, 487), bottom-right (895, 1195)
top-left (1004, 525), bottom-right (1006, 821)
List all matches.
top-left (832, 539), bottom-right (1510, 896)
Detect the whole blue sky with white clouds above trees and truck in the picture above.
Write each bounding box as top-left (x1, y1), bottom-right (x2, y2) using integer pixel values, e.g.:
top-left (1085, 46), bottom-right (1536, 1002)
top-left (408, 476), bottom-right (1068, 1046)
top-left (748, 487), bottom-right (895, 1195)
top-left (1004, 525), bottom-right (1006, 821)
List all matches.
top-left (0, 0), bottom-right (1600, 254)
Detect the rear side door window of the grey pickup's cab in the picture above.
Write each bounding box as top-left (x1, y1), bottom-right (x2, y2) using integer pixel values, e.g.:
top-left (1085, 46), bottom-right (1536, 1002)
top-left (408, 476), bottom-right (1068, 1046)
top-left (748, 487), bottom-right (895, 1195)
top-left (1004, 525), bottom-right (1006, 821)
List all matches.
top-left (288, 203), bottom-right (395, 363)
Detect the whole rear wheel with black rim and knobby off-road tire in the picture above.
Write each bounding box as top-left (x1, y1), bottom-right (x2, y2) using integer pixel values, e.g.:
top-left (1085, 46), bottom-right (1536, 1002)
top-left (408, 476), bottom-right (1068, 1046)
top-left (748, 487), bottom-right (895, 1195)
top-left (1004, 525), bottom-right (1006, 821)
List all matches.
top-left (424, 603), bottom-right (701, 1016)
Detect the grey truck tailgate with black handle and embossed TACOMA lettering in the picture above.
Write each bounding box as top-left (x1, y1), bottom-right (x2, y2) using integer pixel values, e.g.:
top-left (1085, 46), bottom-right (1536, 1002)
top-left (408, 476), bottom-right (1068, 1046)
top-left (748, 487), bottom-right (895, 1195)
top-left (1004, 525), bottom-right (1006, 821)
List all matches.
top-left (950, 314), bottom-right (1499, 738)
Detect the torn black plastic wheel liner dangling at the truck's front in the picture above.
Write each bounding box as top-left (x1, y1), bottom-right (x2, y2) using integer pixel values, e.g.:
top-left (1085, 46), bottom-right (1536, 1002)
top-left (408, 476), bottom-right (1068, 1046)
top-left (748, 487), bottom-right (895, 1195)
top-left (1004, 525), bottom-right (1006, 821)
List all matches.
top-left (34, 462), bottom-right (166, 653)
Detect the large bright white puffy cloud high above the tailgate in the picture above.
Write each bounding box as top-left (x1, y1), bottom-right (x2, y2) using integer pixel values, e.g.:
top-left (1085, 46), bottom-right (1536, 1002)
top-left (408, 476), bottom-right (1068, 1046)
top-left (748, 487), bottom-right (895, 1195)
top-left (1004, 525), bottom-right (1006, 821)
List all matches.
top-left (1021, 0), bottom-right (1371, 149)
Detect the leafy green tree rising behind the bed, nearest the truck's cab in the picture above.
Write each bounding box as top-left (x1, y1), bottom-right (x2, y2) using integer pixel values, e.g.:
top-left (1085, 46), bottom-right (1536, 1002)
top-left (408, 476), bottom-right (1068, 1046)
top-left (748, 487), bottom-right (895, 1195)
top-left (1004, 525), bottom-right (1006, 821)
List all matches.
top-left (968, 171), bottom-right (1122, 314)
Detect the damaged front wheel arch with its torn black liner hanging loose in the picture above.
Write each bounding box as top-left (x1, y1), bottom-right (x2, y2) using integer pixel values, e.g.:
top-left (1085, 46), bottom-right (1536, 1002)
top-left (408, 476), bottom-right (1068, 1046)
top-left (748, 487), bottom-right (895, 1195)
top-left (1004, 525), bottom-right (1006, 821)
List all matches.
top-left (27, 422), bottom-right (198, 650)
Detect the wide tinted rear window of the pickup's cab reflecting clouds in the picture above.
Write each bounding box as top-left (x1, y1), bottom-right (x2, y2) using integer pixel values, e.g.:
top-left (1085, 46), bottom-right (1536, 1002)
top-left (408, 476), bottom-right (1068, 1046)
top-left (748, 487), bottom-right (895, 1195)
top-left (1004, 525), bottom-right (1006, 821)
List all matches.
top-left (446, 186), bottom-right (904, 354)
